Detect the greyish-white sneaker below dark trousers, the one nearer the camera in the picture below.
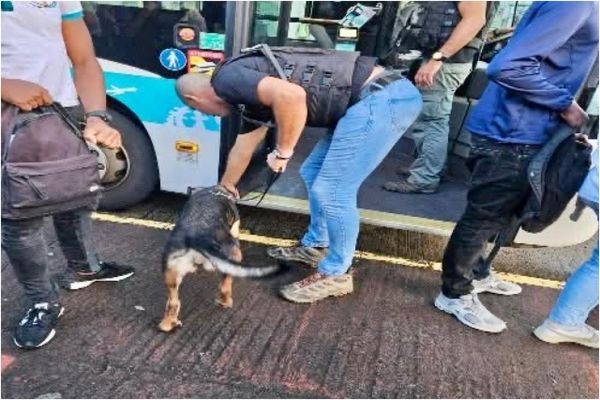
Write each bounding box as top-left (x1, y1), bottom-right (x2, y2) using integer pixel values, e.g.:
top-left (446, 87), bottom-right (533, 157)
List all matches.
top-left (434, 293), bottom-right (506, 333)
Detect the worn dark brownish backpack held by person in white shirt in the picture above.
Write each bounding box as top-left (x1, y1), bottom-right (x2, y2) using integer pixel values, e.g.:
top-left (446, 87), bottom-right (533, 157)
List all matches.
top-left (2, 103), bottom-right (101, 219)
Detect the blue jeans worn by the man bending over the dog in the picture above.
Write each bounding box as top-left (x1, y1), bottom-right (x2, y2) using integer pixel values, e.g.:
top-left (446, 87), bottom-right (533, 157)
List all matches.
top-left (300, 79), bottom-right (422, 275)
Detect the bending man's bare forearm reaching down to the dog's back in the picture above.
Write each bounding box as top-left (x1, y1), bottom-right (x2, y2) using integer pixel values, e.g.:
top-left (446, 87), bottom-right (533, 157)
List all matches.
top-left (221, 126), bottom-right (268, 197)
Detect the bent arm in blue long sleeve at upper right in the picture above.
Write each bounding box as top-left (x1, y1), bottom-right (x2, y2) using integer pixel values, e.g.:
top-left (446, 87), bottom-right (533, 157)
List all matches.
top-left (487, 2), bottom-right (591, 112)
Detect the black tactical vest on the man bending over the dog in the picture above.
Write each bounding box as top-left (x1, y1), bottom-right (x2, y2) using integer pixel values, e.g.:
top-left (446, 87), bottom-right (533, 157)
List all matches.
top-left (213, 46), bottom-right (360, 127)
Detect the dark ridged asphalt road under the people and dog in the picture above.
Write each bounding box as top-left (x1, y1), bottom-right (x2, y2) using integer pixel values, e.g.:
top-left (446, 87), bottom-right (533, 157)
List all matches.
top-left (1, 211), bottom-right (599, 398)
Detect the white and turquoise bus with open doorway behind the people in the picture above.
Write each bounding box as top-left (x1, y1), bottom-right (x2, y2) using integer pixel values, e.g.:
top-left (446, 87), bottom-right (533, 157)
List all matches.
top-left (82, 1), bottom-right (598, 246)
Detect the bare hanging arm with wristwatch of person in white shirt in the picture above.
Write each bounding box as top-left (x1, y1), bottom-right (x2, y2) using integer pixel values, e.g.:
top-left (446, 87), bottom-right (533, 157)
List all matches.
top-left (62, 18), bottom-right (121, 148)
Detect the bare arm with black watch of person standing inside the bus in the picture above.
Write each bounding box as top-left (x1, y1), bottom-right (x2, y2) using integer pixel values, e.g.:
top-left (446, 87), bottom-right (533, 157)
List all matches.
top-left (415, 1), bottom-right (486, 87)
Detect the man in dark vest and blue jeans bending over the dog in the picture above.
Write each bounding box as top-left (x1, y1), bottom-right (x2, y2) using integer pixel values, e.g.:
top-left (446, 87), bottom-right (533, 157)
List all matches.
top-left (177, 48), bottom-right (422, 303)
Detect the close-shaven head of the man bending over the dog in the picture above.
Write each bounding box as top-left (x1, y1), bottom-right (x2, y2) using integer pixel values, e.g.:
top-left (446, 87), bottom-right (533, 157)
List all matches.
top-left (175, 73), bottom-right (231, 117)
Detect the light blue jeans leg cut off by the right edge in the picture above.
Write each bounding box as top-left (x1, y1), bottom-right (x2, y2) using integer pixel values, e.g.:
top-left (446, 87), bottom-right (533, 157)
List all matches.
top-left (550, 203), bottom-right (598, 326)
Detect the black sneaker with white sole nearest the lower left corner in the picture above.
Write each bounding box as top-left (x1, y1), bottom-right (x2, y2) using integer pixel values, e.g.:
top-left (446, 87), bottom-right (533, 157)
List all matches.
top-left (13, 303), bottom-right (65, 350)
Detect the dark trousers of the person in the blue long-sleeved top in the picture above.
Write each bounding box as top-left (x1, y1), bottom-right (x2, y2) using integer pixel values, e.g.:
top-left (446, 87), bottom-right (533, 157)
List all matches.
top-left (442, 134), bottom-right (541, 298)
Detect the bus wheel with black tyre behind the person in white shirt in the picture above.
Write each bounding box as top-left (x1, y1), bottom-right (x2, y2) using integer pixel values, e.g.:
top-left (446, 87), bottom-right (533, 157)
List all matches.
top-left (92, 97), bottom-right (159, 210)
